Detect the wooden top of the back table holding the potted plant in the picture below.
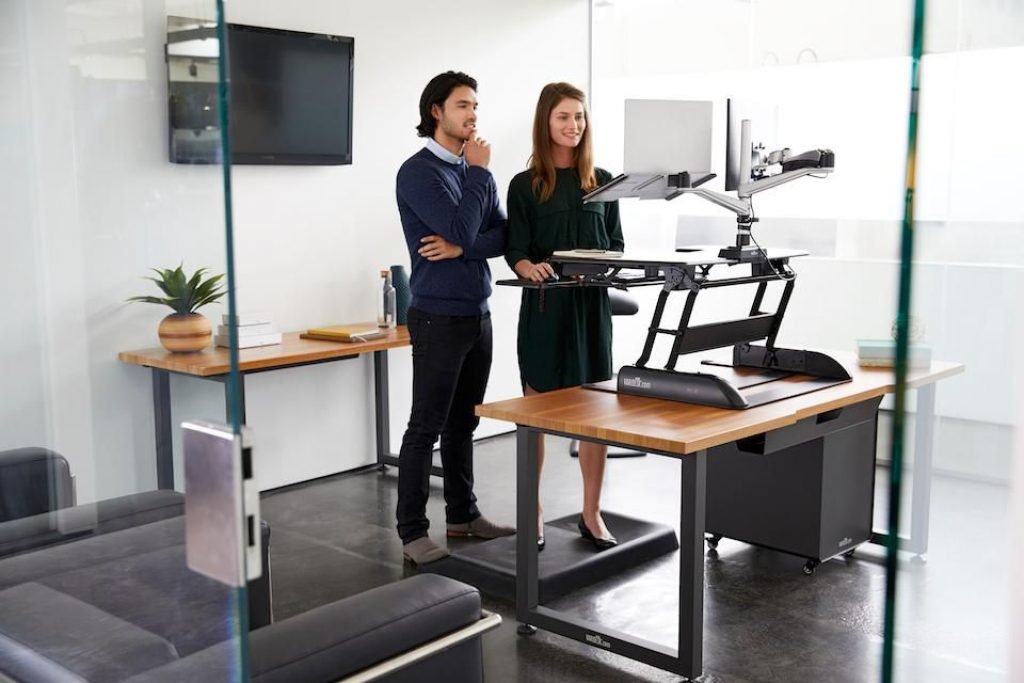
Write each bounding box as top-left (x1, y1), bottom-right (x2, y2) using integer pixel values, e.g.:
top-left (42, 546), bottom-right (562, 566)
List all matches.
top-left (118, 323), bottom-right (410, 377)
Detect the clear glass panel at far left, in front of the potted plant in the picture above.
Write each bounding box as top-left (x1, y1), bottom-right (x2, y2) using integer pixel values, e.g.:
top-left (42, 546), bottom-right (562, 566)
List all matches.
top-left (0, 0), bottom-right (249, 681)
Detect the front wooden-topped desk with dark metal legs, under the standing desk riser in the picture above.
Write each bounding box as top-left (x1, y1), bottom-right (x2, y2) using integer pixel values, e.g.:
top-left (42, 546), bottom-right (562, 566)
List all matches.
top-left (476, 356), bottom-right (963, 679)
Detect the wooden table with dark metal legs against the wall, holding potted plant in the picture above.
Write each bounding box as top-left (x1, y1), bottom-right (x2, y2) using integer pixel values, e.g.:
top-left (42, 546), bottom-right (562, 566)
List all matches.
top-left (118, 323), bottom-right (411, 488)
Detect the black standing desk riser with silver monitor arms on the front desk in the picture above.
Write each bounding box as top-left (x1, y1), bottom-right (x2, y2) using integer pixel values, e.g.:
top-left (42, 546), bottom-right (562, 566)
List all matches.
top-left (498, 121), bottom-right (839, 409)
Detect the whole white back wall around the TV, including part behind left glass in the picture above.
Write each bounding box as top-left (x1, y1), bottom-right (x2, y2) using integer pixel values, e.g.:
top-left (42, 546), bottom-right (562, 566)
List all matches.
top-left (0, 0), bottom-right (589, 501)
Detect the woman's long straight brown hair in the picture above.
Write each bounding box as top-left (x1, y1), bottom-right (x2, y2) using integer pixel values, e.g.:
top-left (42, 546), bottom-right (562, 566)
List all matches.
top-left (529, 83), bottom-right (597, 204)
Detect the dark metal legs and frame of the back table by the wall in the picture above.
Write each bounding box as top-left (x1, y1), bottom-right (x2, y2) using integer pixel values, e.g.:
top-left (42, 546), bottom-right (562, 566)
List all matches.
top-left (151, 350), bottom-right (441, 489)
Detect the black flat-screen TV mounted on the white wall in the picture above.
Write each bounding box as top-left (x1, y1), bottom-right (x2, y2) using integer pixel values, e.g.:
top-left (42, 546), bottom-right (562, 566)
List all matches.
top-left (162, 19), bottom-right (354, 165)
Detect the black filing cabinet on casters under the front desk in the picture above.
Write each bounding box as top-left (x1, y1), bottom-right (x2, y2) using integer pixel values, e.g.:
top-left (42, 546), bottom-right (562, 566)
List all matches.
top-left (706, 398), bottom-right (882, 573)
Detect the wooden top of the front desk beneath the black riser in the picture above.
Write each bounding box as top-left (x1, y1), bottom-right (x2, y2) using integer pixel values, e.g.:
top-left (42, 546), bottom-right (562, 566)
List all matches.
top-left (476, 353), bottom-right (964, 455)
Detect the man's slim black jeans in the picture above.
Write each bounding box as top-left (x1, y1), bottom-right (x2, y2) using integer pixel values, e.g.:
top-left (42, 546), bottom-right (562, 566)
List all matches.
top-left (397, 308), bottom-right (492, 543)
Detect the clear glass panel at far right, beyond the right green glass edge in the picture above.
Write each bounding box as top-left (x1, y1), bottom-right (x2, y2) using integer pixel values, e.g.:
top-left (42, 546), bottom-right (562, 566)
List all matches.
top-left (888, 0), bottom-right (1024, 681)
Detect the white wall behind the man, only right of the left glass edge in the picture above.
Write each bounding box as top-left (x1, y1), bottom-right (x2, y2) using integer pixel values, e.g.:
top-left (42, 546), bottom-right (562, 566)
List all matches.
top-left (228, 0), bottom-right (589, 487)
